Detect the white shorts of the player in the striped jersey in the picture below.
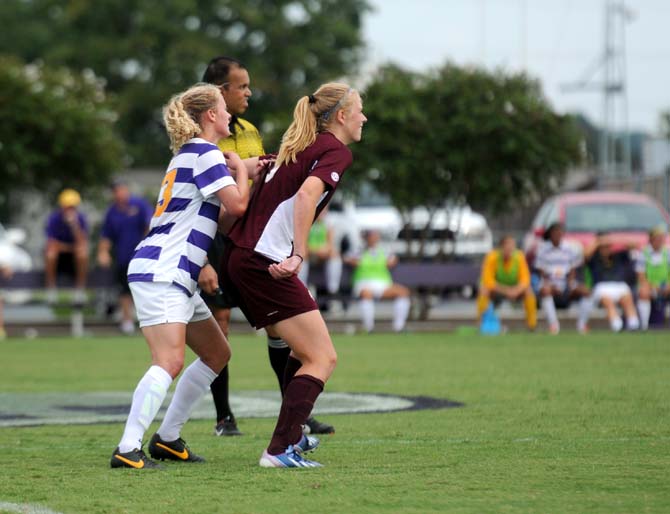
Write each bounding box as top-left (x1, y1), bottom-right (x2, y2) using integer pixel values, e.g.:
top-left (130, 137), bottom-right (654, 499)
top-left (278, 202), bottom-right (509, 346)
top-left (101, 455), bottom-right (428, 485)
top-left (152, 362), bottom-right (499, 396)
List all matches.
top-left (130, 282), bottom-right (212, 327)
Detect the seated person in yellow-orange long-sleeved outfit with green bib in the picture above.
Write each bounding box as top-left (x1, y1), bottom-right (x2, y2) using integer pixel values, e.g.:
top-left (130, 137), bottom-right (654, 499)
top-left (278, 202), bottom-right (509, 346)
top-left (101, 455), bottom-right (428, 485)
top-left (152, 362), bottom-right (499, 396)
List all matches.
top-left (477, 235), bottom-right (537, 330)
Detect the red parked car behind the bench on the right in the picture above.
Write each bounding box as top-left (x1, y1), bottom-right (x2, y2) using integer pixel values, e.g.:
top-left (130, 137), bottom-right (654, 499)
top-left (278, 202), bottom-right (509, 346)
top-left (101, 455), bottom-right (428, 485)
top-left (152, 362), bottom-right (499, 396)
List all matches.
top-left (523, 191), bottom-right (670, 263)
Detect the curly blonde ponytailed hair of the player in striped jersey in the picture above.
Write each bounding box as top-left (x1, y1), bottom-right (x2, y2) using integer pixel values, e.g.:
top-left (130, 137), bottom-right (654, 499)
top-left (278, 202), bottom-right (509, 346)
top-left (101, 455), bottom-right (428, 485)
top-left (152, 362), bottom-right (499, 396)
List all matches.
top-left (163, 84), bottom-right (221, 153)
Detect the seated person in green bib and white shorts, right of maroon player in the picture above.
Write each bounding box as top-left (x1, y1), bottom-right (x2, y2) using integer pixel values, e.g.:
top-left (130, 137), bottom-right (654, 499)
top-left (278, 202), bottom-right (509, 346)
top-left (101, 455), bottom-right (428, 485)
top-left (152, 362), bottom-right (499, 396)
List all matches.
top-left (346, 230), bottom-right (410, 332)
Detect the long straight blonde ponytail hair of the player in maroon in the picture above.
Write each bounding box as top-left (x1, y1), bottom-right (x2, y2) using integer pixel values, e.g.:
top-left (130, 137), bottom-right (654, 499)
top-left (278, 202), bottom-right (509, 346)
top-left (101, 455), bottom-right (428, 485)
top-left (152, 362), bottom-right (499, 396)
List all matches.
top-left (277, 82), bottom-right (355, 166)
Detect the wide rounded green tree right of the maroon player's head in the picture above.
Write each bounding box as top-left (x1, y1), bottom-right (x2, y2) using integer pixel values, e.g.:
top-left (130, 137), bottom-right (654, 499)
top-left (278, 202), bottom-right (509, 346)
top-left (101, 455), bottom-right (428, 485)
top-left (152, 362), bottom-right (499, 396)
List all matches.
top-left (352, 64), bottom-right (580, 258)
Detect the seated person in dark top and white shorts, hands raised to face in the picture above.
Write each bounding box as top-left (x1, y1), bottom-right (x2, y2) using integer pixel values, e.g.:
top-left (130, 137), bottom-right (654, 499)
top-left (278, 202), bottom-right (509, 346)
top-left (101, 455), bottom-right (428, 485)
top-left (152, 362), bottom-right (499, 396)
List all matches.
top-left (584, 234), bottom-right (640, 332)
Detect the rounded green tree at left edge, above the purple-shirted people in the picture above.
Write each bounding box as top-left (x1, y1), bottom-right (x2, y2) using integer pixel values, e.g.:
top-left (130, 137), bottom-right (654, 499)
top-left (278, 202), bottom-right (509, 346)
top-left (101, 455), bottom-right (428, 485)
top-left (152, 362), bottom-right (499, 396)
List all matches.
top-left (0, 57), bottom-right (122, 218)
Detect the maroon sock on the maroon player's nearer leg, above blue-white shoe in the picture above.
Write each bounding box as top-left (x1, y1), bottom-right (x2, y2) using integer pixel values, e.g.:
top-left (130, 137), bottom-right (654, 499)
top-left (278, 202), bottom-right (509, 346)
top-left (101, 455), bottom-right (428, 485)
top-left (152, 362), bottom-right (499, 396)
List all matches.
top-left (268, 375), bottom-right (323, 455)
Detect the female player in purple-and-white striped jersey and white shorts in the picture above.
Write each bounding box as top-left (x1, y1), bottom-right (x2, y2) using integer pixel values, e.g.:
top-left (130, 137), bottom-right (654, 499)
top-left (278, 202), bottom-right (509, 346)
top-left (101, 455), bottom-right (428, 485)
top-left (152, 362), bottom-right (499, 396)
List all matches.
top-left (111, 85), bottom-right (253, 469)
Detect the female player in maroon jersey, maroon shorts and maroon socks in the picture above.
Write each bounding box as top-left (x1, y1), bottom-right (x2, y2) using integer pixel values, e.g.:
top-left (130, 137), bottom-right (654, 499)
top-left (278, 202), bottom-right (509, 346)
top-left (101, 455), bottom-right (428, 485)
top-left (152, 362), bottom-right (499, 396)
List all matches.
top-left (222, 83), bottom-right (367, 467)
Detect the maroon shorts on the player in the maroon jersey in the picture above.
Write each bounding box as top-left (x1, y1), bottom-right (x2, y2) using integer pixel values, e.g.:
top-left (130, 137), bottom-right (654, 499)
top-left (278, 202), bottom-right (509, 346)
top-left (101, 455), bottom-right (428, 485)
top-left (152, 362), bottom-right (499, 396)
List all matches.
top-left (221, 244), bottom-right (319, 328)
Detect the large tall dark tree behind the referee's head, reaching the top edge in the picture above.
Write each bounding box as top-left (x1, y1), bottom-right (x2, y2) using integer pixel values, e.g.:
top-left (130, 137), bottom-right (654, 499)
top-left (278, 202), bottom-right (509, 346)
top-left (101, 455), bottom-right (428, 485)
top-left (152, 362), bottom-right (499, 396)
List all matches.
top-left (0, 0), bottom-right (368, 166)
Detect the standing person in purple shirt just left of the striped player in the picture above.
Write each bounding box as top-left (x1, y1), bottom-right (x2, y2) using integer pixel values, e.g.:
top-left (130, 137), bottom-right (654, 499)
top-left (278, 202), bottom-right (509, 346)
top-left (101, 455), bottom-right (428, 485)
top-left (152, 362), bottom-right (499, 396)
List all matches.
top-left (98, 181), bottom-right (153, 334)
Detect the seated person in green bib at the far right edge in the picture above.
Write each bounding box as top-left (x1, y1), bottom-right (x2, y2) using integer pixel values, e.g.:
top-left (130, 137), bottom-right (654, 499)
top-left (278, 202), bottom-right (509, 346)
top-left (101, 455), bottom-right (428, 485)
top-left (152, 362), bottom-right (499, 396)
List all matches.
top-left (635, 225), bottom-right (670, 330)
